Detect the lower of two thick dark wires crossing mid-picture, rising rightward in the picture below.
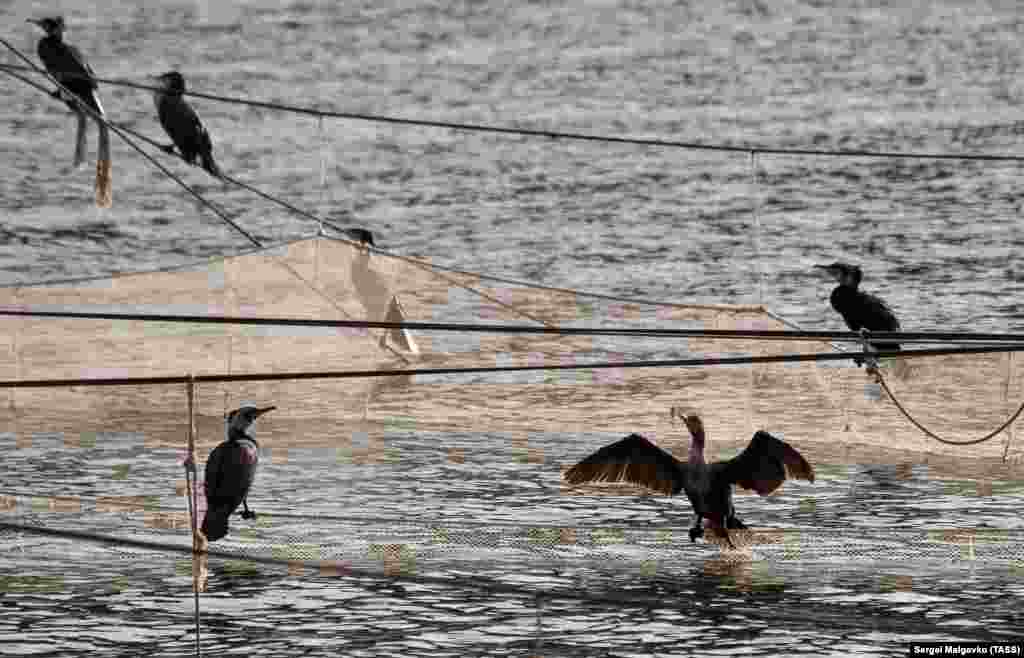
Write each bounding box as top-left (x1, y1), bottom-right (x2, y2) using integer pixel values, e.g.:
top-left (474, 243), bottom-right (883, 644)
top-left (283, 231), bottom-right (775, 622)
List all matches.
top-left (0, 345), bottom-right (1011, 388)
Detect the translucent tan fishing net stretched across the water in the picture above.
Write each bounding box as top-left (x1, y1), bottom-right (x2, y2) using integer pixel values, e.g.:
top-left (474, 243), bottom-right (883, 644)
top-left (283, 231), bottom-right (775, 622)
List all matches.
top-left (0, 237), bottom-right (1024, 654)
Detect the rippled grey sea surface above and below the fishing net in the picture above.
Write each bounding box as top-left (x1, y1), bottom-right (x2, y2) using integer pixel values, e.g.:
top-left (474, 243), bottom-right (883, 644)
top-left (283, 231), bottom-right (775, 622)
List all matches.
top-left (0, 0), bottom-right (1024, 656)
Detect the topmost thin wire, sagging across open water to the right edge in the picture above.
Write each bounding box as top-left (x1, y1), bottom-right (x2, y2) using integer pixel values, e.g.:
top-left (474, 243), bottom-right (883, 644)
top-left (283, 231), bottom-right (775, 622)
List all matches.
top-left (0, 64), bottom-right (1024, 162)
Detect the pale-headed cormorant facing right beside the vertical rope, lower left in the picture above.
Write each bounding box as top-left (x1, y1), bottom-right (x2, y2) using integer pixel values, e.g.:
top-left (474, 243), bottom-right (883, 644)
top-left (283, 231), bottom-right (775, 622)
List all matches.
top-left (203, 406), bottom-right (276, 541)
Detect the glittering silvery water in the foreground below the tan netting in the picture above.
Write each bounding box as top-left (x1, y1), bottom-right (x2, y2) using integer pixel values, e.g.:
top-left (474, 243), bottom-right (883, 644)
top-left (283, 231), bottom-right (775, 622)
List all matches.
top-left (0, 430), bottom-right (1024, 656)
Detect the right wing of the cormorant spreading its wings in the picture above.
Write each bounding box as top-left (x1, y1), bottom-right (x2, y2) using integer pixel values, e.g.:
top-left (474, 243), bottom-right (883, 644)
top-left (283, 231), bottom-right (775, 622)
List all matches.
top-left (712, 430), bottom-right (814, 495)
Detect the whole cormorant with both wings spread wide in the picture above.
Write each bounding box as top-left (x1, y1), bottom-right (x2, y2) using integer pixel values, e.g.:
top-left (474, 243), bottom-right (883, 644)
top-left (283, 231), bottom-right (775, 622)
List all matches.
top-left (564, 407), bottom-right (814, 547)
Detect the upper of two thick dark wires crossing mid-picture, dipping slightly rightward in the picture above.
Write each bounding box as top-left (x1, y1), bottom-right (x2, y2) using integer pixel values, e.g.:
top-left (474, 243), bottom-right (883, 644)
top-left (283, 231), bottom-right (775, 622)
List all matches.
top-left (0, 306), bottom-right (1024, 346)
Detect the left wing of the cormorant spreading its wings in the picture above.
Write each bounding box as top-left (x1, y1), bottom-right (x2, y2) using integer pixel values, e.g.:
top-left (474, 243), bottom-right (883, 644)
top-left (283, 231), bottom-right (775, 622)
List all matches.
top-left (564, 434), bottom-right (686, 495)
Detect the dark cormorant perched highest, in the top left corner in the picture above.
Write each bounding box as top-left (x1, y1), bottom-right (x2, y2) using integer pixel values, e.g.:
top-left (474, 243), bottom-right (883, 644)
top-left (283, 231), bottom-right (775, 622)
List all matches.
top-left (28, 16), bottom-right (113, 208)
